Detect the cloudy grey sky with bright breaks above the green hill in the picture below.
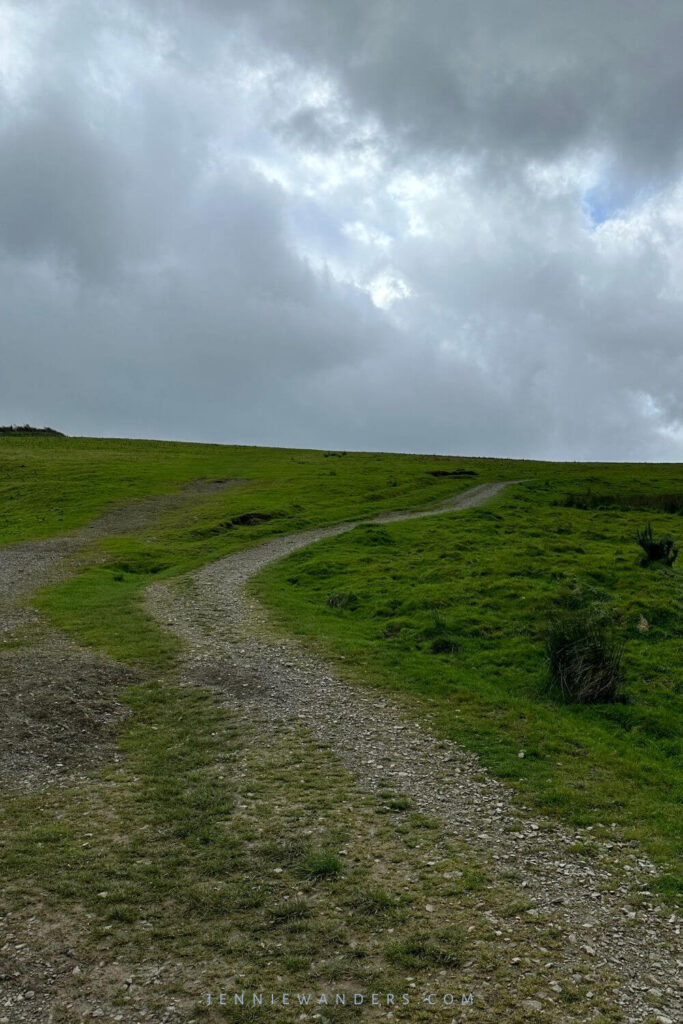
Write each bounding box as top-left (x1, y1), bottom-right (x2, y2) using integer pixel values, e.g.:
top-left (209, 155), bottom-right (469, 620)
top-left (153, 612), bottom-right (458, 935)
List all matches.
top-left (0, 0), bottom-right (683, 462)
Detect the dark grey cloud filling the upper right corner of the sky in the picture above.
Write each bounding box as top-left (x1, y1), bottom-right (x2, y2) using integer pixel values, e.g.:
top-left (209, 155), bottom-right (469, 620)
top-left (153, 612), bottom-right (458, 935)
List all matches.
top-left (188, 0), bottom-right (683, 175)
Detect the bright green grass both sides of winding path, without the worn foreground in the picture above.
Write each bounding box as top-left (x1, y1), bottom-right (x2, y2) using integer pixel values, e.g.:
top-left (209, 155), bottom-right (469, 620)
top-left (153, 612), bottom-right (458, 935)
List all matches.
top-left (0, 436), bottom-right (683, 887)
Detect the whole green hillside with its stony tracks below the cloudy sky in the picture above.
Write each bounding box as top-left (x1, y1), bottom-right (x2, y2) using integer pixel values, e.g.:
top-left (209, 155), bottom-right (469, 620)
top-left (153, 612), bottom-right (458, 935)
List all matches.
top-left (0, 435), bottom-right (683, 1024)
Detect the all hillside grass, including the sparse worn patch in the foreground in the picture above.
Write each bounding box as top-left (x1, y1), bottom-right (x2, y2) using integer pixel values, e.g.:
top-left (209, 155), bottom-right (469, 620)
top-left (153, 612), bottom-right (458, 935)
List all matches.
top-left (0, 436), bottom-right (683, 1007)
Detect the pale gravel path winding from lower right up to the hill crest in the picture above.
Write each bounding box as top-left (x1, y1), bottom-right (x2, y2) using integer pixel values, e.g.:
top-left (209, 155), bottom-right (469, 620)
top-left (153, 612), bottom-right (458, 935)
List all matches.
top-left (148, 484), bottom-right (683, 1024)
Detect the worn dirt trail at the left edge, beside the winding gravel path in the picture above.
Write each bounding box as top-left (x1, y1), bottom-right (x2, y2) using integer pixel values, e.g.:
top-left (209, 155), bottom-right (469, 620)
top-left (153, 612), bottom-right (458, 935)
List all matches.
top-left (0, 479), bottom-right (243, 788)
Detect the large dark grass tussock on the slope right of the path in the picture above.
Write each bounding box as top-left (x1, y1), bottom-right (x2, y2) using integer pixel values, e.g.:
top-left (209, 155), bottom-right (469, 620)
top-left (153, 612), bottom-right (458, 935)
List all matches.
top-left (546, 610), bottom-right (624, 705)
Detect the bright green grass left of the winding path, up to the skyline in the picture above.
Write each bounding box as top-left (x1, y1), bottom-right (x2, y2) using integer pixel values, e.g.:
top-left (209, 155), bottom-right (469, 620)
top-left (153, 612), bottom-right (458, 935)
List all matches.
top-left (0, 436), bottom-right (519, 668)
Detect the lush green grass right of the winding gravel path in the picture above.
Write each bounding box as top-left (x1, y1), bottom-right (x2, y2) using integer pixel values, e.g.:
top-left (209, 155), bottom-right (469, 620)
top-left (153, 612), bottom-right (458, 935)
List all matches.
top-left (252, 466), bottom-right (683, 893)
